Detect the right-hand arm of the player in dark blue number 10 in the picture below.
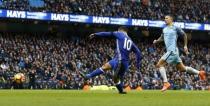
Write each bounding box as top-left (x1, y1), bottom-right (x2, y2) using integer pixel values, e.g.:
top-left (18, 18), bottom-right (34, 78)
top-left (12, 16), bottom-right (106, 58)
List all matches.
top-left (132, 44), bottom-right (141, 70)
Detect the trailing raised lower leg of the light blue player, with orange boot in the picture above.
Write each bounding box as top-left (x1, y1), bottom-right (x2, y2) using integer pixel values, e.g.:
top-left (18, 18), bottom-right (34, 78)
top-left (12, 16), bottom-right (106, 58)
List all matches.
top-left (177, 63), bottom-right (206, 80)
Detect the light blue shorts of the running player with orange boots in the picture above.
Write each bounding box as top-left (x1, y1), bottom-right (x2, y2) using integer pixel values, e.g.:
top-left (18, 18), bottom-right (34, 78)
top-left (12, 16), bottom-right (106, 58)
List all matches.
top-left (161, 51), bottom-right (182, 64)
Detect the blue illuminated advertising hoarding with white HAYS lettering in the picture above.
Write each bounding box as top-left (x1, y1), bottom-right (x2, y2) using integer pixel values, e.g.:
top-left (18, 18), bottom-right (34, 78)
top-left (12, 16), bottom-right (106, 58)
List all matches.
top-left (0, 9), bottom-right (210, 31)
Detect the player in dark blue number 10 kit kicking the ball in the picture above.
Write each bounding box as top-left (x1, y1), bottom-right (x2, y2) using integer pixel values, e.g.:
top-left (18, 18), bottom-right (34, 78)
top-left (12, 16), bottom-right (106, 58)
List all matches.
top-left (79, 26), bottom-right (141, 94)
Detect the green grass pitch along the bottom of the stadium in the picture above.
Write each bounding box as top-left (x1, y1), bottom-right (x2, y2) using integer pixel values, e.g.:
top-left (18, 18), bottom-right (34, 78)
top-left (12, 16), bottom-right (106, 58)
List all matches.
top-left (0, 90), bottom-right (210, 106)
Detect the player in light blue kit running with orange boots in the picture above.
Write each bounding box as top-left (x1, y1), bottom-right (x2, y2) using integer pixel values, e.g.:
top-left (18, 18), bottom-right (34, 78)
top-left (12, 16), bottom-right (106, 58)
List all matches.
top-left (153, 15), bottom-right (206, 91)
